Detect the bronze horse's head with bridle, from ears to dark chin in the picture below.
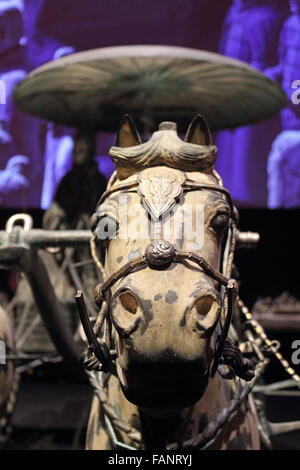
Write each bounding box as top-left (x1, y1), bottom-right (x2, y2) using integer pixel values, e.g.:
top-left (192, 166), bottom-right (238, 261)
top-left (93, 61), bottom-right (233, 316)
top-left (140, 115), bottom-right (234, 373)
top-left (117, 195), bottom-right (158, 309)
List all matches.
top-left (94, 116), bottom-right (235, 410)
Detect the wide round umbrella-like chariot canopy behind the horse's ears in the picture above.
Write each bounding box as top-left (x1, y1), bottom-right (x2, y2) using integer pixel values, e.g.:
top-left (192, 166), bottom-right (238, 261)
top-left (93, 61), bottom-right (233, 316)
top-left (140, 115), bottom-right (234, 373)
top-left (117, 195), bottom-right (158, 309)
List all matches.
top-left (14, 45), bottom-right (286, 132)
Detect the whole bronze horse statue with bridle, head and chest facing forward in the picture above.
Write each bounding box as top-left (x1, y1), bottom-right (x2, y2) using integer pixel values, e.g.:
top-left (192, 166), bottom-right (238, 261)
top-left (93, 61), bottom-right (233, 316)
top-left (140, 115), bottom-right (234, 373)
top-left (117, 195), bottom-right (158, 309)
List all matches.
top-left (77, 116), bottom-right (260, 449)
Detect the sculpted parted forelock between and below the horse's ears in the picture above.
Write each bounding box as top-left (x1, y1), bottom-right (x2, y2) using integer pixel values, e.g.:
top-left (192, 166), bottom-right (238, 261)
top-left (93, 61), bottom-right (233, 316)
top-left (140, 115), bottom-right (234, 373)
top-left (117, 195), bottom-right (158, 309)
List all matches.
top-left (109, 129), bottom-right (217, 179)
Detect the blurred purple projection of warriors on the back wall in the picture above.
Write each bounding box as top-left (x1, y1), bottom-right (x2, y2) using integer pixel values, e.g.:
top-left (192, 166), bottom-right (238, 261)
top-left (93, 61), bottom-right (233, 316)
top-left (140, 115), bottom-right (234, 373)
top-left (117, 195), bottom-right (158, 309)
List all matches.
top-left (0, 0), bottom-right (300, 210)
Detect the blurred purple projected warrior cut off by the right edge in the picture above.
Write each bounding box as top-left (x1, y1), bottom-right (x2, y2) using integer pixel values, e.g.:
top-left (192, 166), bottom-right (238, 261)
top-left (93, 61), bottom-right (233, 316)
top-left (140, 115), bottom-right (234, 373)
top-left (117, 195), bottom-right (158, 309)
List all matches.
top-left (266, 0), bottom-right (300, 209)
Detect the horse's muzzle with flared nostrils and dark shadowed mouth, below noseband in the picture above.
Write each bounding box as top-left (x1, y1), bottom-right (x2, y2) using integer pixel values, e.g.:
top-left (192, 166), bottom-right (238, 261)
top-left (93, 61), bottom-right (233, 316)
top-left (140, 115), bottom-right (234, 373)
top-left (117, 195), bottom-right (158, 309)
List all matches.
top-left (112, 290), bottom-right (221, 409)
